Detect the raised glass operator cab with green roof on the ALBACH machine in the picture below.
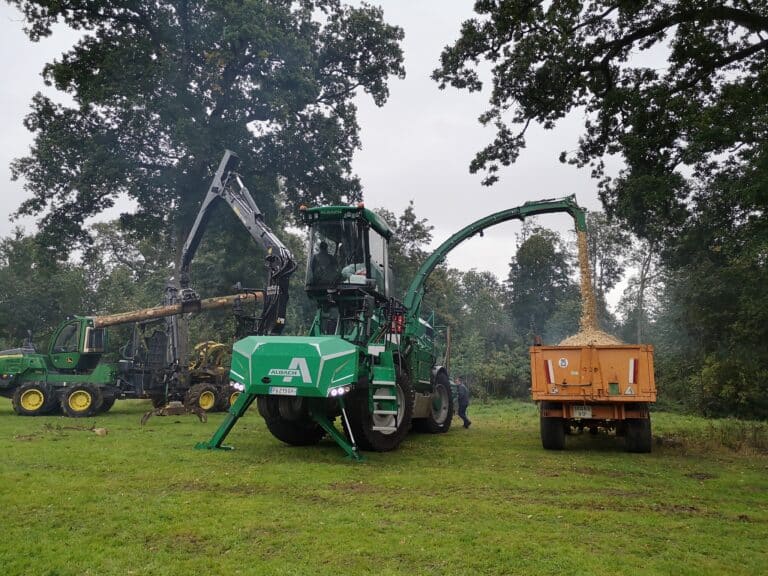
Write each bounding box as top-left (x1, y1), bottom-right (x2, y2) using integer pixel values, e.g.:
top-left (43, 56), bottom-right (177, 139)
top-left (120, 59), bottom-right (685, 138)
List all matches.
top-left (302, 206), bottom-right (392, 299)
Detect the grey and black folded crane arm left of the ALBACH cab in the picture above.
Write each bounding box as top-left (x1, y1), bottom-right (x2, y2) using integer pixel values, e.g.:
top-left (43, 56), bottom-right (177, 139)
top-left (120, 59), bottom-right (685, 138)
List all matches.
top-left (172, 150), bottom-right (296, 334)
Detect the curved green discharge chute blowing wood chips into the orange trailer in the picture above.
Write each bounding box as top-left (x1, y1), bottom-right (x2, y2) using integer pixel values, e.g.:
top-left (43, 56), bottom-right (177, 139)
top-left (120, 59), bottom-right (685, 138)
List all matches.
top-left (403, 194), bottom-right (587, 333)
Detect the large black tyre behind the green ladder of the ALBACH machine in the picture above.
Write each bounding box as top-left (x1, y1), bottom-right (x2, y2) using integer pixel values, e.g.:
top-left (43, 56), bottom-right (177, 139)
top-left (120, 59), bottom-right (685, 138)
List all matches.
top-left (346, 369), bottom-right (414, 452)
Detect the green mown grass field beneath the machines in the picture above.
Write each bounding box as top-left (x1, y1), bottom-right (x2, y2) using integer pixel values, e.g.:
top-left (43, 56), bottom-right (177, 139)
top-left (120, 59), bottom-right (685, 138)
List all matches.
top-left (0, 399), bottom-right (768, 576)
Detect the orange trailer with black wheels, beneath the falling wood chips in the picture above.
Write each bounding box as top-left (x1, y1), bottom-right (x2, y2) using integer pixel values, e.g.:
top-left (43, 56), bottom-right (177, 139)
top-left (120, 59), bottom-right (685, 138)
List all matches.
top-left (531, 344), bottom-right (656, 452)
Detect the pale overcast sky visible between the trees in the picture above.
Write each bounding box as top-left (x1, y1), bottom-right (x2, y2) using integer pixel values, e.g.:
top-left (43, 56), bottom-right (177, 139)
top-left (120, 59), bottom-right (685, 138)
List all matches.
top-left (0, 0), bottom-right (612, 279)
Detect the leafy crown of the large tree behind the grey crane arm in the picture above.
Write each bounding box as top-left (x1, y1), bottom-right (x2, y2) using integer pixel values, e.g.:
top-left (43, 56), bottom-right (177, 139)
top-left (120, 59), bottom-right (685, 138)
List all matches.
top-left (8, 0), bottom-right (404, 251)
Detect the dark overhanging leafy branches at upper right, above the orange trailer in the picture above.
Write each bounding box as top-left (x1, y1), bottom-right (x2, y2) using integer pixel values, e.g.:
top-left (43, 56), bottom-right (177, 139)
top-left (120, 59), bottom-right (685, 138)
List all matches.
top-left (433, 0), bottom-right (768, 239)
